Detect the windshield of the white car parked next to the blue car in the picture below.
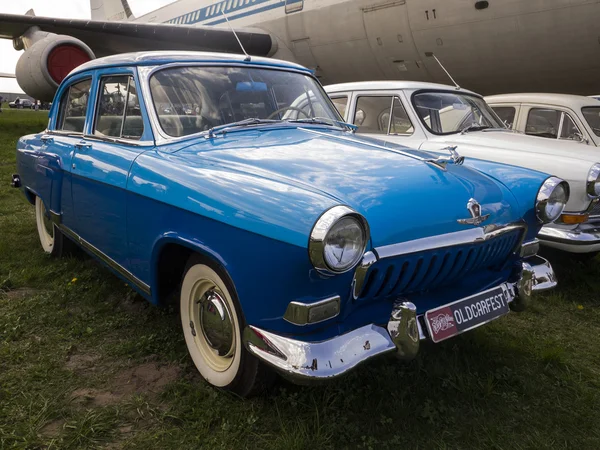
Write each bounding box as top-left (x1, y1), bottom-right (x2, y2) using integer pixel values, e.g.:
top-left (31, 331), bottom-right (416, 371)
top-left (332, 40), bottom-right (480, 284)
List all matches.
top-left (413, 92), bottom-right (506, 134)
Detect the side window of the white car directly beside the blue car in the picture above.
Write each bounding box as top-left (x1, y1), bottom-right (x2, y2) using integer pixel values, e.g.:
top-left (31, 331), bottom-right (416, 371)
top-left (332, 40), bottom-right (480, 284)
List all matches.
top-left (353, 96), bottom-right (414, 134)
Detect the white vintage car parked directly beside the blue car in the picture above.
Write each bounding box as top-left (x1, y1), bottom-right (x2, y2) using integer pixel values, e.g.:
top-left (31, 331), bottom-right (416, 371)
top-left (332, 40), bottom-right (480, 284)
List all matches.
top-left (325, 81), bottom-right (600, 255)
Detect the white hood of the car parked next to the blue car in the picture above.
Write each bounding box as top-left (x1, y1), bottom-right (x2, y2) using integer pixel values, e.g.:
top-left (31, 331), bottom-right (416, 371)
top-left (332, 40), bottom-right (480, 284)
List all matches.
top-left (421, 130), bottom-right (600, 211)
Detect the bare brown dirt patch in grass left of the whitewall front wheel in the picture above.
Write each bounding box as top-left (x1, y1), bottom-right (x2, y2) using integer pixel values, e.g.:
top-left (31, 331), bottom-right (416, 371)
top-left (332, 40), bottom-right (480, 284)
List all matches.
top-left (71, 363), bottom-right (180, 406)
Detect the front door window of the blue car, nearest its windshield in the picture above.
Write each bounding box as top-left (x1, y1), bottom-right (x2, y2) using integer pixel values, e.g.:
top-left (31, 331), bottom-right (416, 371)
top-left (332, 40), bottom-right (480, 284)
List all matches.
top-left (94, 75), bottom-right (144, 139)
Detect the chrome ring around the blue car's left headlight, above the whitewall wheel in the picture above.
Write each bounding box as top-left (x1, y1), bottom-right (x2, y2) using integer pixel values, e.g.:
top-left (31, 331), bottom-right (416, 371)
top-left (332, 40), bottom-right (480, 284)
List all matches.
top-left (308, 205), bottom-right (370, 275)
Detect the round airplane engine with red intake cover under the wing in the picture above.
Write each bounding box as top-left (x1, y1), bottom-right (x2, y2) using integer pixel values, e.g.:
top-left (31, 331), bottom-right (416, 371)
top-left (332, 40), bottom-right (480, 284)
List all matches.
top-left (15, 33), bottom-right (96, 101)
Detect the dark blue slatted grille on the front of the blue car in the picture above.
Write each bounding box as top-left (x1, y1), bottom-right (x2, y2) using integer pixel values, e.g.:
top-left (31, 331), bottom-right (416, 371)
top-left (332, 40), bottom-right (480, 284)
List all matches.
top-left (358, 230), bottom-right (522, 299)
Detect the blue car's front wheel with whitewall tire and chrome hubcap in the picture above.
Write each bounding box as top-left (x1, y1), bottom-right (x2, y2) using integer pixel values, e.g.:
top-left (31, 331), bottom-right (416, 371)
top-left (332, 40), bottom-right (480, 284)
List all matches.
top-left (180, 256), bottom-right (270, 397)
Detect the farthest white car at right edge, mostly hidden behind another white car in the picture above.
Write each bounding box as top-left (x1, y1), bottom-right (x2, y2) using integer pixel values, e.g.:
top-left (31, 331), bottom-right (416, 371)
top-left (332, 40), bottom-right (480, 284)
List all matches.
top-left (485, 94), bottom-right (600, 147)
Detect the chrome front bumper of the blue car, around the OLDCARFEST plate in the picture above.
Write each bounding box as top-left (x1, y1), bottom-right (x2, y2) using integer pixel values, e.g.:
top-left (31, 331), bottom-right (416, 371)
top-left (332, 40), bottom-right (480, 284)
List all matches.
top-left (243, 256), bottom-right (556, 384)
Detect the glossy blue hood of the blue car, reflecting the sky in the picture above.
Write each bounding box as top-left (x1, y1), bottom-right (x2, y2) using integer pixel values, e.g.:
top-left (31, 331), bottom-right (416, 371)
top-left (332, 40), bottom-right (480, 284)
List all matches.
top-left (174, 127), bottom-right (521, 246)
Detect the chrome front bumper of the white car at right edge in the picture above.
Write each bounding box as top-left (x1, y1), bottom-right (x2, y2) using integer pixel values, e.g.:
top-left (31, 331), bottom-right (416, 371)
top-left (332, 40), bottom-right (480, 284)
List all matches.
top-left (538, 223), bottom-right (600, 253)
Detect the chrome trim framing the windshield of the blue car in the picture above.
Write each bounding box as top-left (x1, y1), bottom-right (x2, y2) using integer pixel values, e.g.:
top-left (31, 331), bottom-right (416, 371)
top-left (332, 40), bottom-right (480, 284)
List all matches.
top-left (138, 59), bottom-right (324, 145)
